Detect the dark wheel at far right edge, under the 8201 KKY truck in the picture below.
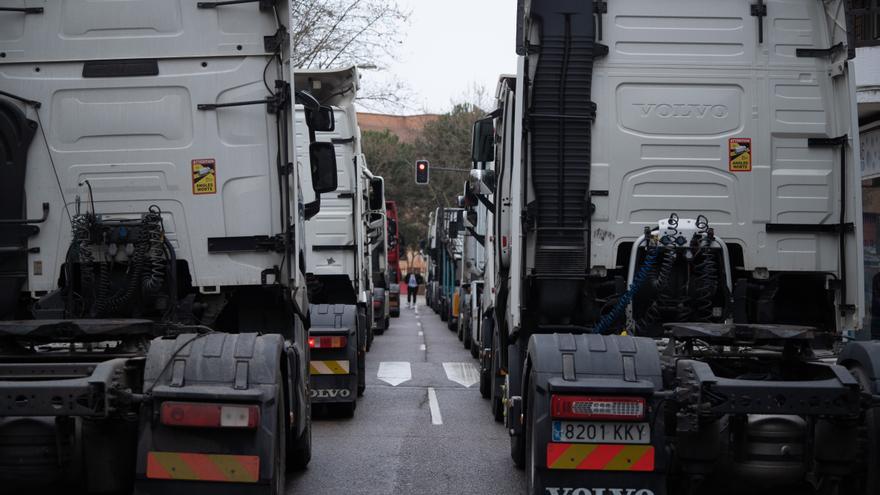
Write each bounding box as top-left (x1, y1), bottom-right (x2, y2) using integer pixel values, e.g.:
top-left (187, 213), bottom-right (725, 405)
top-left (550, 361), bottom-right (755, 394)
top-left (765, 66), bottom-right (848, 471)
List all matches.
top-left (840, 366), bottom-right (880, 495)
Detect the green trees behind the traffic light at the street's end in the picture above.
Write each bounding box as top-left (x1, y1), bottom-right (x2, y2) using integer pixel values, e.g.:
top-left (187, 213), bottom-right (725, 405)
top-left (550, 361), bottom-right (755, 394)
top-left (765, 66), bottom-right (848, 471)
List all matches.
top-left (362, 104), bottom-right (485, 254)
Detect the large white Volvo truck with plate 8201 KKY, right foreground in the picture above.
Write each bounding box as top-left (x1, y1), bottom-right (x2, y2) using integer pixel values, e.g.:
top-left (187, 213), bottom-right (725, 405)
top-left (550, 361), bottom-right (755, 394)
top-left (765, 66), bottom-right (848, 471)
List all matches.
top-left (470, 0), bottom-right (880, 495)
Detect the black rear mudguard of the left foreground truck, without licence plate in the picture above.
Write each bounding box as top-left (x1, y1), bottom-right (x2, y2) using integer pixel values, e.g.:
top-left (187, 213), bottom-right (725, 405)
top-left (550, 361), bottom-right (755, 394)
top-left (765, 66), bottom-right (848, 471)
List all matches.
top-left (135, 333), bottom-right (286, 495)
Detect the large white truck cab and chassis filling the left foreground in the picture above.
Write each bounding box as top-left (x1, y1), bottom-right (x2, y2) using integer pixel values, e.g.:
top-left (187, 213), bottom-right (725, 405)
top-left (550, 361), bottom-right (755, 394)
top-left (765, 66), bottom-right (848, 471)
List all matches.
top-left (0, 1), bottom-right (336, 495)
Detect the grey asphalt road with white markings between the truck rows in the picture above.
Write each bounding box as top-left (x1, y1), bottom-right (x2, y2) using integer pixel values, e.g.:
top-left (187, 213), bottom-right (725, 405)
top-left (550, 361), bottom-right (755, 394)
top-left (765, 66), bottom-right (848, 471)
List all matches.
top-left (288, 299), bottom-right (525, 495)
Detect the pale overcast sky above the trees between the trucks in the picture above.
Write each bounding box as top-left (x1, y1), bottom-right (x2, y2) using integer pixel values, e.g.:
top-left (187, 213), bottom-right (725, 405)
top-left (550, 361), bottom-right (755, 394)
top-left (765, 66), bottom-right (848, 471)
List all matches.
top-left (364, 0), bottom-right (516, 114)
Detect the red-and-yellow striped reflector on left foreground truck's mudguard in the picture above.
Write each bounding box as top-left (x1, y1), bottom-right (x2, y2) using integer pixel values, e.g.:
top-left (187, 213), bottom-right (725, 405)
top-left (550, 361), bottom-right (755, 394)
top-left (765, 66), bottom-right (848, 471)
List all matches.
top-left (147, 452), bottom-right (260, 483)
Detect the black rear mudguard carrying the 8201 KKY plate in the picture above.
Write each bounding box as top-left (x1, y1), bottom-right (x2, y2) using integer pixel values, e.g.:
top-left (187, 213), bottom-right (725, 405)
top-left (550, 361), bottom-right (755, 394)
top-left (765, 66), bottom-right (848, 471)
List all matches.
top-left (524, 334), bottom-right (668, 495)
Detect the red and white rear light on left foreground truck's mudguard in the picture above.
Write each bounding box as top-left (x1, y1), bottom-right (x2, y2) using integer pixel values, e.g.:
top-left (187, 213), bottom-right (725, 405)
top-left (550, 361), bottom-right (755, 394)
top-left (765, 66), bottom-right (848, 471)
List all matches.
top-left (160, 402), bottom-right (260, 429)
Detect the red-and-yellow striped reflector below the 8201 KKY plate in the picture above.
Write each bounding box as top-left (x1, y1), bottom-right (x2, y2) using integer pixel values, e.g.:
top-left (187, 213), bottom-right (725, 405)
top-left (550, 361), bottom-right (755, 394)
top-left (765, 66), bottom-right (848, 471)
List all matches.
top-left (547, 443), bottom-right (654, 471)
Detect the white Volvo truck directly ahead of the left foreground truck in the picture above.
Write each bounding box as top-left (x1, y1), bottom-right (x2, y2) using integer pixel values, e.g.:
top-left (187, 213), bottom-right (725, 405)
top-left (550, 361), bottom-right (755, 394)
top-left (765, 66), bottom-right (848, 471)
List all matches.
top-left (295, 67), bottom-right (372, 416)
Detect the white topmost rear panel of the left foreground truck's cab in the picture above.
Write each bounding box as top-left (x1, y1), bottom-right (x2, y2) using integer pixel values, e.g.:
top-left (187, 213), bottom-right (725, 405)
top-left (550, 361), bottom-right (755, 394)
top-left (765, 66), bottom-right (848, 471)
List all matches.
top-left (0, 0), bottom-right (276, 64)
